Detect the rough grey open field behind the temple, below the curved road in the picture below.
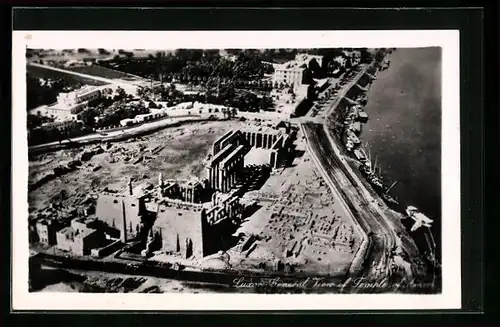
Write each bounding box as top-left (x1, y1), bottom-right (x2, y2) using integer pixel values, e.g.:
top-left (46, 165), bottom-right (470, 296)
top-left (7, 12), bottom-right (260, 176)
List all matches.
top-left (28, 121), bottom-right (240, 211)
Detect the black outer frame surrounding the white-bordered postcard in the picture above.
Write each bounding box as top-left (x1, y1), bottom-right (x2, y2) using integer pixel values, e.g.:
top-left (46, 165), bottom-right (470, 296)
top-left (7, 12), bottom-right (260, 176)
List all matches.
top-left (2, 7), bottom-right (492, 326)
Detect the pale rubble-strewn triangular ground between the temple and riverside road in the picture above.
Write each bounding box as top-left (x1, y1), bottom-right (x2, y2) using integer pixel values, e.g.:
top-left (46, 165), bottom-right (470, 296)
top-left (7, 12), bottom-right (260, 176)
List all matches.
top-left (228, 135), bottom-right (361, 275)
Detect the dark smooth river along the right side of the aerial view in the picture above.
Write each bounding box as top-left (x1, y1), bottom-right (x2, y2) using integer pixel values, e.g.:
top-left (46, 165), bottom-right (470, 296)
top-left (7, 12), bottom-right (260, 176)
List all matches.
top-left (361, 47), bottom-right (441, 257)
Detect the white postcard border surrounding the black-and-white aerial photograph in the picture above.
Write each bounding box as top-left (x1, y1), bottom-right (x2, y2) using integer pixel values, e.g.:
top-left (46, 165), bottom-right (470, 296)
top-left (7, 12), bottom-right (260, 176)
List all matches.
top-left (12, 30), bottom-right (461, 310)
